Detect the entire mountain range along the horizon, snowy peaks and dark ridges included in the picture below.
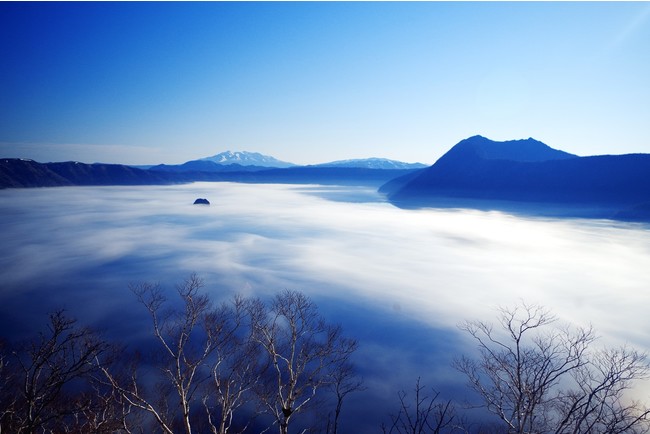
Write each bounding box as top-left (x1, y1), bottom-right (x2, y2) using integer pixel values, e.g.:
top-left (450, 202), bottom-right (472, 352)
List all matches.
top-left (0, 136), bottom-right (650, 221)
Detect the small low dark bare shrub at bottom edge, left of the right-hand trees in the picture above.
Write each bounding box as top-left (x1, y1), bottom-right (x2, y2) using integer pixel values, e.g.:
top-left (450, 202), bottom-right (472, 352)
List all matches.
top-left (381, 378), bottom-right (457, 434)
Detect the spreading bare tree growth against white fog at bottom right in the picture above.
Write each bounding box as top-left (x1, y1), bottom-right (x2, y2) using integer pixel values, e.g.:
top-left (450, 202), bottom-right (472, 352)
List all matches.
top-left (455, 303), bottom-right (648, 433)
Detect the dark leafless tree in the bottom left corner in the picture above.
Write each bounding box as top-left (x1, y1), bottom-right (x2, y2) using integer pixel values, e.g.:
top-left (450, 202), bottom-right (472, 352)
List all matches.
top-left (0, 311), bottom-right (108, 434)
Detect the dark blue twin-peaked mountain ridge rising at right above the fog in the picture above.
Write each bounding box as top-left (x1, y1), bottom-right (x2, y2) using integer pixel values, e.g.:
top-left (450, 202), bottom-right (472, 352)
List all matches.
top-left (380, 136), bottom-right (650, 220)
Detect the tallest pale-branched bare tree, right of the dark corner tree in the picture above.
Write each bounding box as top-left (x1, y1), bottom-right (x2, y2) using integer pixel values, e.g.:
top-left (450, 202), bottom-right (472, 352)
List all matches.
top-left (102, 274), bottom-right (260, 434)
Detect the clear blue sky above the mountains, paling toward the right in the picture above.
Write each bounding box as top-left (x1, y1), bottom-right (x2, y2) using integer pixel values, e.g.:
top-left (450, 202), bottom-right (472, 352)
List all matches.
top-left (0, 2), bottom-right (650, 164)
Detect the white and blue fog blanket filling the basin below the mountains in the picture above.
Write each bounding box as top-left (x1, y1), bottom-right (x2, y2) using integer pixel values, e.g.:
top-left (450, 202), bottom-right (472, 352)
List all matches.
top-left (0, 183), bottom-right (650, 426)
